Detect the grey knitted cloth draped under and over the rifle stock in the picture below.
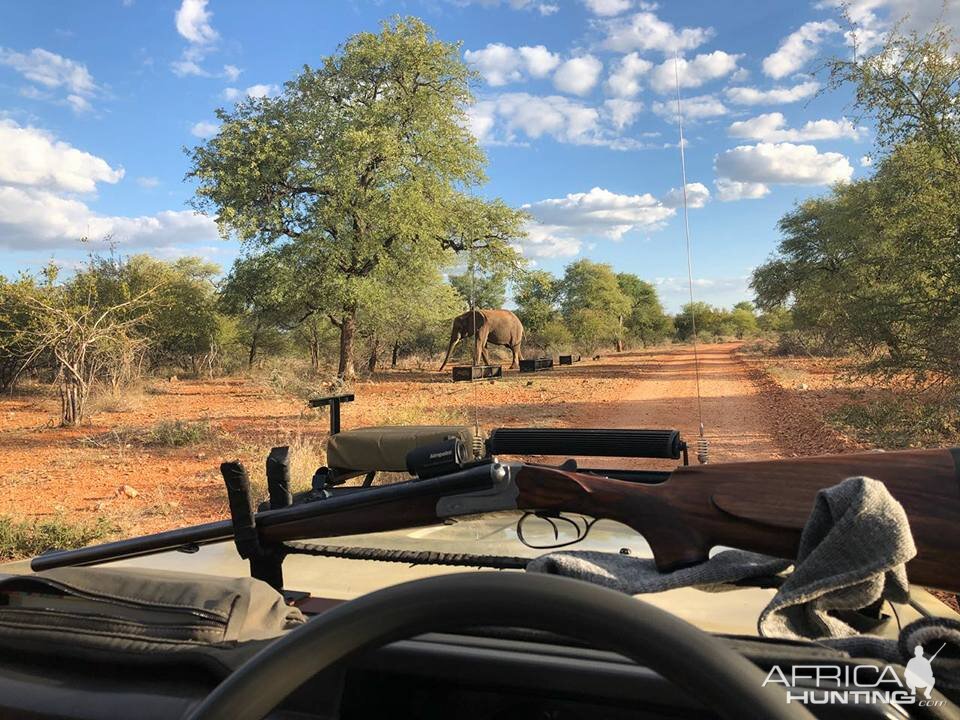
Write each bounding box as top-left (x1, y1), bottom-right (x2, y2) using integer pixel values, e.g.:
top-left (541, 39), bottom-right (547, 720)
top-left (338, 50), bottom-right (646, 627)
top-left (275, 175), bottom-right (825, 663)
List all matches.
top-left (527, 477), bottom-right (917, 639)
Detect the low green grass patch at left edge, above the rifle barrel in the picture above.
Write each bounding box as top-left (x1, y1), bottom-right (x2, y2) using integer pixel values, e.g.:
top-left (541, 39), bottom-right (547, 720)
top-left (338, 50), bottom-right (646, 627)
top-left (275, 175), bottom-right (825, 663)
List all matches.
top-left (0, 515), bottom-right (117, 561)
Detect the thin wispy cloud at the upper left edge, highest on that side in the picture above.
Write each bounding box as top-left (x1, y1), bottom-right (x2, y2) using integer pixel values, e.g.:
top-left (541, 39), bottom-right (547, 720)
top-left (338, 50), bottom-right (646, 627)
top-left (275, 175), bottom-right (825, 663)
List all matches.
top-left (0, 48), bottom-right (100, 113)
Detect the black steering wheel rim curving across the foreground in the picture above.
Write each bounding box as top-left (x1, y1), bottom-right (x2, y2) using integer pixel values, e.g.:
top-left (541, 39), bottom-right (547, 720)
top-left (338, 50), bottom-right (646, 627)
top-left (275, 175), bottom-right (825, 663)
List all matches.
top-left (187, 572), bottom-right (813, 720)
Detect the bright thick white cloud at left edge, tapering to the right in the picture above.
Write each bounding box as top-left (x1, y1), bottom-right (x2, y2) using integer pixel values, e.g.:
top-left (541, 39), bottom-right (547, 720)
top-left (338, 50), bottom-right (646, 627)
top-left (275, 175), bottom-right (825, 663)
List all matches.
top-left (0, 120), bottom-right (123, 193)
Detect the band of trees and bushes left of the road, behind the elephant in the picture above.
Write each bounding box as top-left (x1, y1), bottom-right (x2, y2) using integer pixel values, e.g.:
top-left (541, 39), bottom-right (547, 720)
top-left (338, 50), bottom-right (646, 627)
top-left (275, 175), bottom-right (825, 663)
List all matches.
top-left (0, 18), bottom-right (764, 434)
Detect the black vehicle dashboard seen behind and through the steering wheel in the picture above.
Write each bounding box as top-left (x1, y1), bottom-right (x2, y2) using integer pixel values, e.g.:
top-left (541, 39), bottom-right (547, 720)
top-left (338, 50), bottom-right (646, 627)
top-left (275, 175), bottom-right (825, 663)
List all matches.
top-left (0, 629), bottom-right (936, 720)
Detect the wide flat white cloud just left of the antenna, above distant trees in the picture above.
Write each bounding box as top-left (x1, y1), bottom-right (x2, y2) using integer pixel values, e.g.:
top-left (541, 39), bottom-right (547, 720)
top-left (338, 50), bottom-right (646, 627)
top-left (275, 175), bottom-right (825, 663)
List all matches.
top-left (523, 187), bottom-right (676, 240)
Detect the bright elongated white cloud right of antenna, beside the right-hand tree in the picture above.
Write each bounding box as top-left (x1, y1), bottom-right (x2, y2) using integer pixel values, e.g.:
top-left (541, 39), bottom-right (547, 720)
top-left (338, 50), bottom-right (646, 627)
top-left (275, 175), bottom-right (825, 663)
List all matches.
top-left (715, 143), bottom-right (853, 185)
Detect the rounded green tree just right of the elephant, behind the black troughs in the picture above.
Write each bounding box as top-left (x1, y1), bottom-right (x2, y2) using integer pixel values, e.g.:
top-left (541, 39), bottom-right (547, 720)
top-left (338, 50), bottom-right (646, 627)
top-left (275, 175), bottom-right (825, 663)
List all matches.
top-left (560, 260), bottom-right (631, 352)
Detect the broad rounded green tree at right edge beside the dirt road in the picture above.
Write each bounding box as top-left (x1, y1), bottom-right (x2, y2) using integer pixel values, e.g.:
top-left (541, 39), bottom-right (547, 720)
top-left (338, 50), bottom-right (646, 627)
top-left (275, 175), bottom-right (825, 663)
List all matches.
top-left (751, 141), bottom-right (960, 380)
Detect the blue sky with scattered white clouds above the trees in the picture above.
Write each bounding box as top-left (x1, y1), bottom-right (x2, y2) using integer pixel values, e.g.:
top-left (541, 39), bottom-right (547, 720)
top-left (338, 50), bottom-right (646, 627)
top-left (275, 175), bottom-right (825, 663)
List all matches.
top-left (0, 0), bottom-right (960, 310)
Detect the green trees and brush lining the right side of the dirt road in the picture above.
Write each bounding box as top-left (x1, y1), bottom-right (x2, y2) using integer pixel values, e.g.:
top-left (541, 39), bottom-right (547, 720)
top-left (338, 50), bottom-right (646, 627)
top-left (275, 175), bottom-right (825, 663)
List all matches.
top-left (752, 26), bottom-right (960, 445)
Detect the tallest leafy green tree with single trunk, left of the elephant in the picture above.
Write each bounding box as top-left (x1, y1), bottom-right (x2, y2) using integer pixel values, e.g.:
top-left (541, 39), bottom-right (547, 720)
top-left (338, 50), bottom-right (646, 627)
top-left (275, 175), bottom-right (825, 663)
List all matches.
top-left (189, 18), bottom-right (524, 376)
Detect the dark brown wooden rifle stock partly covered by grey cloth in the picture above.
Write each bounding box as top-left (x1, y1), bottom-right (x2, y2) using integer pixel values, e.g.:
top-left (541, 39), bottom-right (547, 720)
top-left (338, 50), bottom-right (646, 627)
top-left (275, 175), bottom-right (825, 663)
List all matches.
top-left (515, 449), bottom-right (960, 592)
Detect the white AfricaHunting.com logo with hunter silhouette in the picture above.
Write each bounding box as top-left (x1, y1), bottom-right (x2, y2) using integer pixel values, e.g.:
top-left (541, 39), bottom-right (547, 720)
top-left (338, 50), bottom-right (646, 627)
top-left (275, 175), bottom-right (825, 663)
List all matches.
top-left (763, 645), bottom-right (946, 707)
